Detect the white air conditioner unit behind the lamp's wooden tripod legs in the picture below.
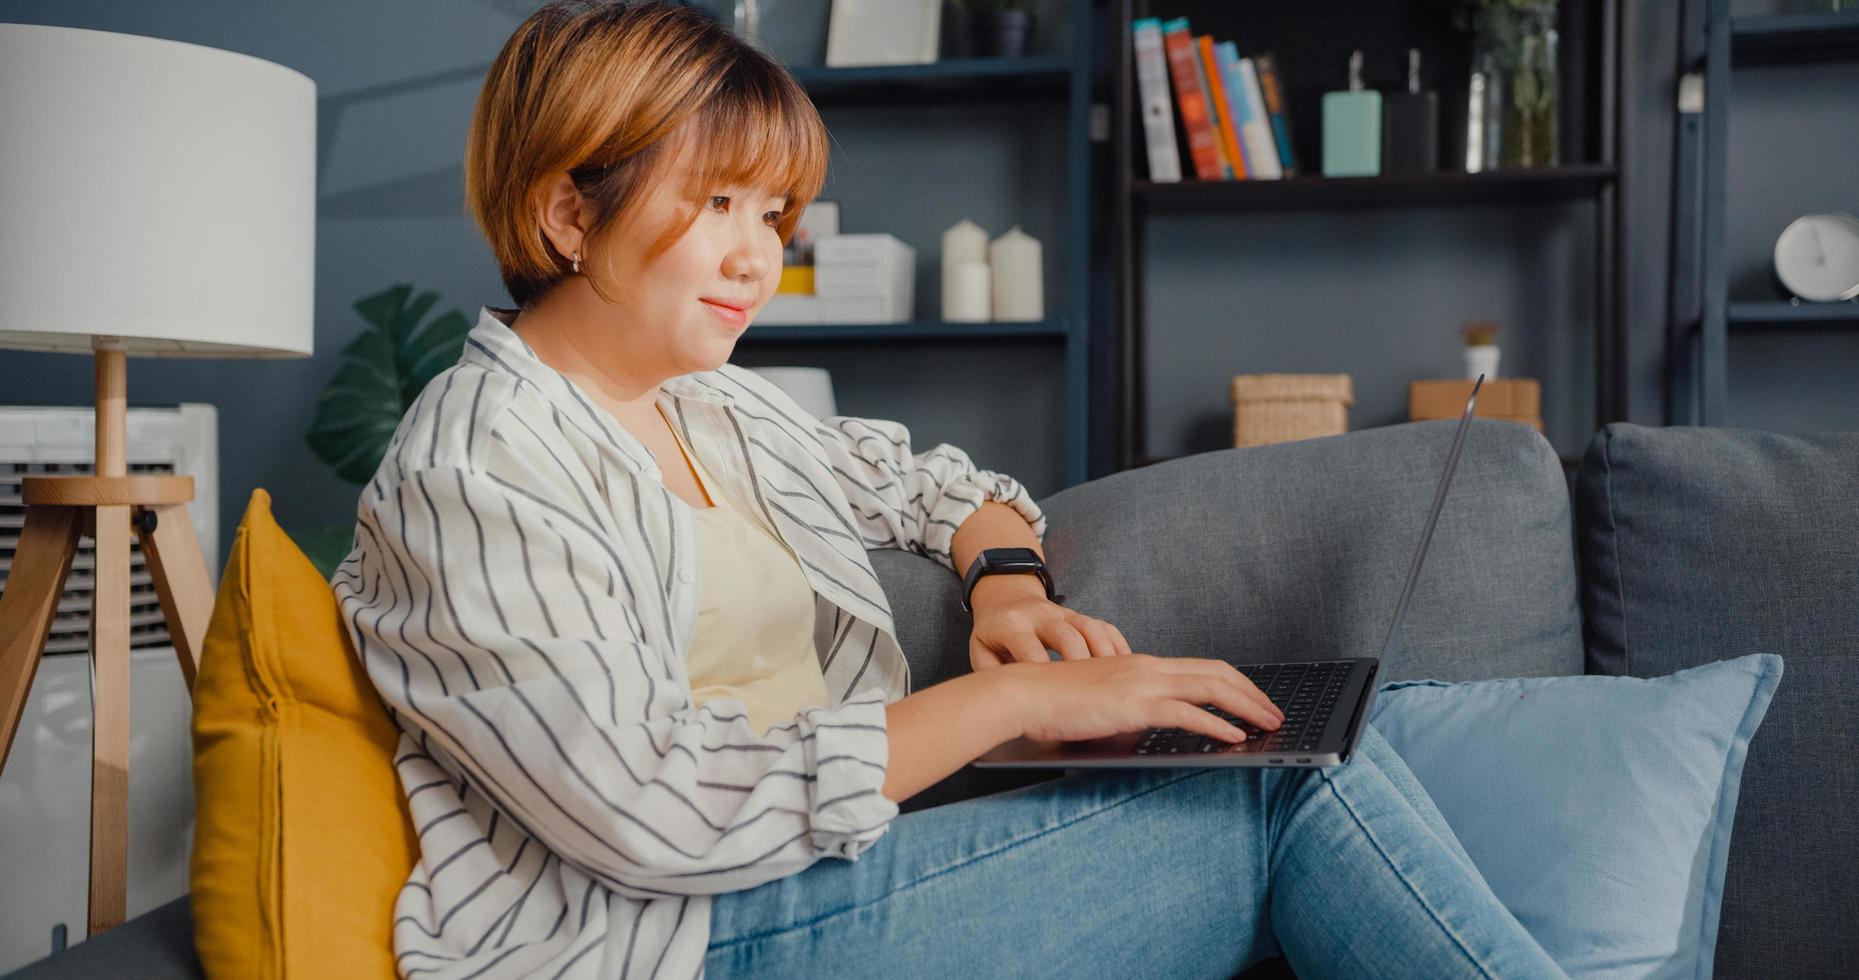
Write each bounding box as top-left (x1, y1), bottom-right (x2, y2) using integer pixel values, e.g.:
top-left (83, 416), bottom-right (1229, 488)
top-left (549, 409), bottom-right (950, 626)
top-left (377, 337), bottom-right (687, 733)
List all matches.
top-left (0, 404), bottom-right (219, 974)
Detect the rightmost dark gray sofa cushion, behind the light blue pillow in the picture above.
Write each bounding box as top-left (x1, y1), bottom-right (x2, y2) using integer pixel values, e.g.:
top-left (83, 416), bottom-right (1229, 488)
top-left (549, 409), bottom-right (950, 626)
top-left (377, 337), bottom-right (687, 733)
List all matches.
top-left (1576, 424), bottom-right (1859, 976)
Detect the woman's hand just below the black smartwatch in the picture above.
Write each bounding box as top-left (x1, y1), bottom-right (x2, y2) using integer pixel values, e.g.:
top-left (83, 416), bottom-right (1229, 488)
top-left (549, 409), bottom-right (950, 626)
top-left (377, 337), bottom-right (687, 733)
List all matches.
top-left (969, 575), bottom-right (1130, 671)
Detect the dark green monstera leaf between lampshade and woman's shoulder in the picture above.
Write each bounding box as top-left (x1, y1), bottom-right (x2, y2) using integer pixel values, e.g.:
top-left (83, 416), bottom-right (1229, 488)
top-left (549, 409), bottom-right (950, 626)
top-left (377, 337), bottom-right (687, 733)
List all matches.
top-left (309, 285), bottom-right (470, 483)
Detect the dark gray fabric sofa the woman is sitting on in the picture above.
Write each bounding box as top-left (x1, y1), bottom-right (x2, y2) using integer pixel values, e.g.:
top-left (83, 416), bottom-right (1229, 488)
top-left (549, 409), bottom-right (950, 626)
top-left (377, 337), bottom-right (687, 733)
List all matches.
top-left (17, 420), bottom-right (1859, 978)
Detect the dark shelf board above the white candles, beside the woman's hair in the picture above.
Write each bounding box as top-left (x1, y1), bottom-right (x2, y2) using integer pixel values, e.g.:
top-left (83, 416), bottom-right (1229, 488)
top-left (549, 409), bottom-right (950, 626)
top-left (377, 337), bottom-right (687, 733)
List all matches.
top-left (788, 54), bottom-right (1071, 108)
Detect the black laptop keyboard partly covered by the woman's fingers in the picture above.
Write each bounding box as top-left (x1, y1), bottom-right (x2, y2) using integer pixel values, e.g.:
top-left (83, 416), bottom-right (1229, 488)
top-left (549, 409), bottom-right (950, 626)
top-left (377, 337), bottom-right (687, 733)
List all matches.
top-left (1136, 660), bottom-right (1355, 755)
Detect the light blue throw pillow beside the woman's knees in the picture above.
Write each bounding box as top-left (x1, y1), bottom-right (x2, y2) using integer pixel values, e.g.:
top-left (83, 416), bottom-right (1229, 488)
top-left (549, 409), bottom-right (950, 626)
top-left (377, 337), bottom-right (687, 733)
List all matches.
top-left (1370, 653), bottom-right (1781, 978)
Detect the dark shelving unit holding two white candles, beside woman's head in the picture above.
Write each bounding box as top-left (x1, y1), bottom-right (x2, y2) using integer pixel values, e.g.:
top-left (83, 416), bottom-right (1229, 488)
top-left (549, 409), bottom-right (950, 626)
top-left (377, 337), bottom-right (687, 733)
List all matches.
top-left (740, 11), bottom-right (1091, 485)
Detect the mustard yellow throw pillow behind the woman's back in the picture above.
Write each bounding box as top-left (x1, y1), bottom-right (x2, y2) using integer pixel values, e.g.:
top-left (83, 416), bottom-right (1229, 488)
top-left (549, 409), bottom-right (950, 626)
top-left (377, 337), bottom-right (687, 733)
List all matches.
top-left (188, 489), bottom-right (418, 978)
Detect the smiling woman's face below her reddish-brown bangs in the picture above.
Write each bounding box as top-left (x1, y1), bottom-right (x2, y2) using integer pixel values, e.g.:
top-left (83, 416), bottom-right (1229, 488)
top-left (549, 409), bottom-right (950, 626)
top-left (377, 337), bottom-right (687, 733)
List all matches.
top-left (584, 162), bottom-right (786, 377)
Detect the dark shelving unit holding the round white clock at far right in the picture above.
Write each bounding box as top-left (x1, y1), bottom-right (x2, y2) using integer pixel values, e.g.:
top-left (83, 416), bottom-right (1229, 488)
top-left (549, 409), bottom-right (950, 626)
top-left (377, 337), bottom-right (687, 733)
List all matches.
top-left (1666, 0), bottom-right (1859, 426)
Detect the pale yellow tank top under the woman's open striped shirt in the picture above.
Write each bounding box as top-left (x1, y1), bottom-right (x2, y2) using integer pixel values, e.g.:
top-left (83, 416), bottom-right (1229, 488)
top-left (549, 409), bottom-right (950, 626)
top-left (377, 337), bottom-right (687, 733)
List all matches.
top-left (658, 409), bottom-right (829, 735)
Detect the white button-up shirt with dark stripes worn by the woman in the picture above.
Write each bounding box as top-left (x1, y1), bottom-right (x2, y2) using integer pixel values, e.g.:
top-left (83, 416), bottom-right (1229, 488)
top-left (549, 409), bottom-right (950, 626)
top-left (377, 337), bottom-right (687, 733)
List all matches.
top-left (333, 307), bottom-right (1045, 978)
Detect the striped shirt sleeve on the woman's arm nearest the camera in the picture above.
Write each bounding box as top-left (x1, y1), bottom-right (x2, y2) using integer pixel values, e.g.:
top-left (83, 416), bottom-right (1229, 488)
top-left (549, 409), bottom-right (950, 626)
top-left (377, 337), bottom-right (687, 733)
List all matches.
top-left (342, 467), bottom-right (898, 898)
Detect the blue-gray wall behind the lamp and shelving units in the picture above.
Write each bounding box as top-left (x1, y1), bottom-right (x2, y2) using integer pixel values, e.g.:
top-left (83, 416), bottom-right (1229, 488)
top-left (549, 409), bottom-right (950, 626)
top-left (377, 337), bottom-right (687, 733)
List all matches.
top-left (0, 0), bottom-right (1859, 572)
